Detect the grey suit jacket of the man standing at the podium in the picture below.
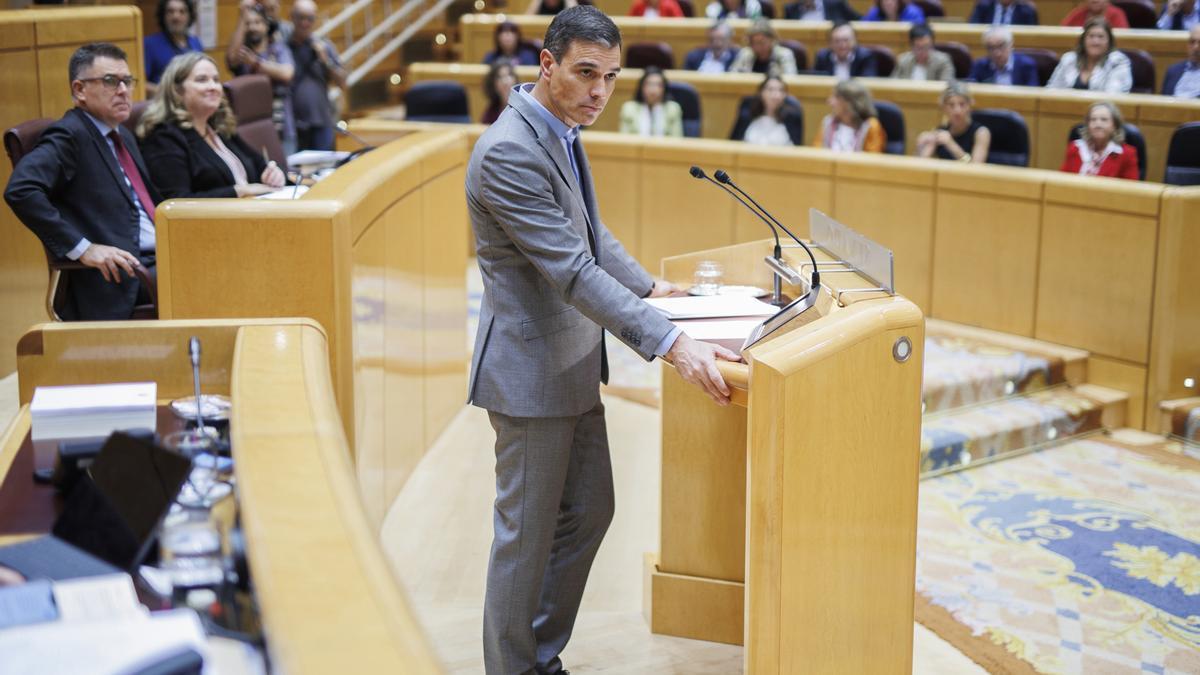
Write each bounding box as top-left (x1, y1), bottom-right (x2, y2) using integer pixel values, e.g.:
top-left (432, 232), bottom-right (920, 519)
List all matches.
top-left (467, 92), bottom-right (672, 417)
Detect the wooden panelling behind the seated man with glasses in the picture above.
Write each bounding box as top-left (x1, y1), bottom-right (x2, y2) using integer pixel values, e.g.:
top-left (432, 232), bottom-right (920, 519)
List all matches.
top-left (0, 6), bottom-right (143, 375)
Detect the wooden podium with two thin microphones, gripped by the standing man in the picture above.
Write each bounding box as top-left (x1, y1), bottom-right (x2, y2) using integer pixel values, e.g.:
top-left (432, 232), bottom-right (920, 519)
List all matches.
top-left (644, 218), bottom-right (924, 675)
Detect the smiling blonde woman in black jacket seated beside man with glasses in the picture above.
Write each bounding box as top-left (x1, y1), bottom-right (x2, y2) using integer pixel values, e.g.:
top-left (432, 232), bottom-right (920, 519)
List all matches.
top-left (138, 52), bottom-right (284, 199)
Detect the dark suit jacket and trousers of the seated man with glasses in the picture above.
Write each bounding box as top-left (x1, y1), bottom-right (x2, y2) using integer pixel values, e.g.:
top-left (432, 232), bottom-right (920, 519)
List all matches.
top-left (4, 108), bottom-right (162, 321)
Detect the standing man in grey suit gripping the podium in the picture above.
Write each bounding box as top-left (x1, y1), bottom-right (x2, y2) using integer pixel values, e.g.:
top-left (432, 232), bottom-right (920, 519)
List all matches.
top-left (467, 5), bottom-right (738, 675)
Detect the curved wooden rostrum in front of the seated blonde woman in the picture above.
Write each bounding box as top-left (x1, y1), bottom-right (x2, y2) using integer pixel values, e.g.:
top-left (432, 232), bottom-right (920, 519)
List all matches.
top-left (151, 129), bottom-right (468, 522)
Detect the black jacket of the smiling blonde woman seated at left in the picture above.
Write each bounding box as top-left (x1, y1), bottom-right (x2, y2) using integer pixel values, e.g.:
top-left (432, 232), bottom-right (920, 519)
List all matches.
top-left (142, 123), bottom-right (266, 199)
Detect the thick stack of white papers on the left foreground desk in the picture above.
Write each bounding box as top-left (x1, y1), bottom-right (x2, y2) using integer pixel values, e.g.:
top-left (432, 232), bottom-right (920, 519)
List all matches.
top-left (29, 382), bottom-right (158, 441)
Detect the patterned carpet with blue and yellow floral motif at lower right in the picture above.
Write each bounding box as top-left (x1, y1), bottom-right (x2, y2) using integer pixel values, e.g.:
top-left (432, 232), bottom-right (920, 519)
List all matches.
top-left (917, 437), bottom-right (1200, 674)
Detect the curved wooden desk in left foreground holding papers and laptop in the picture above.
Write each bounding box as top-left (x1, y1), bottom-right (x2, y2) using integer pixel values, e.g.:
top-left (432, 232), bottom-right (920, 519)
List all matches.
top-left (0, 319), bottom-right (440, 675)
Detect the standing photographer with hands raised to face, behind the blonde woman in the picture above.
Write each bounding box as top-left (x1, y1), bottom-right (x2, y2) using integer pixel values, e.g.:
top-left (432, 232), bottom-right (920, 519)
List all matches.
top-left (226, 5), bottom-right (296, 155)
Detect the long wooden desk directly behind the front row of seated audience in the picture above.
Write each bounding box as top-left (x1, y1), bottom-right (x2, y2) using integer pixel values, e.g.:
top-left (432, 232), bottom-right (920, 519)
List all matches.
top-left (409, 62), bottom-right (1200, 181)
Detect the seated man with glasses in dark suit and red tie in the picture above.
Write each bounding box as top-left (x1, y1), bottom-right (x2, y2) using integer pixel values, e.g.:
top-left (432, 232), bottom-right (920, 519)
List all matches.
top-left (4, 42), bottom-right (162, 321)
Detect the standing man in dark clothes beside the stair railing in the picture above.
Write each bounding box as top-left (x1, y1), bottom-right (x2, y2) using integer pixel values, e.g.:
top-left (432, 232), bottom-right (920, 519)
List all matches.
top-left (288, 0), bottom-right (347, 150)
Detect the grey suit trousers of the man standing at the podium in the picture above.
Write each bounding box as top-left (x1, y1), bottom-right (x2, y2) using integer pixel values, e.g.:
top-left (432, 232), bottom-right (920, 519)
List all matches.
top-left (484, 404), bottom-right (613, 675)
